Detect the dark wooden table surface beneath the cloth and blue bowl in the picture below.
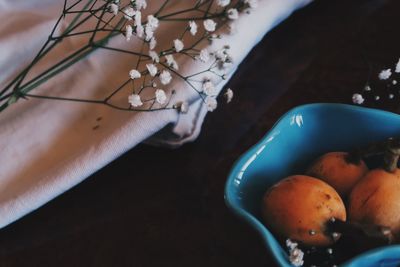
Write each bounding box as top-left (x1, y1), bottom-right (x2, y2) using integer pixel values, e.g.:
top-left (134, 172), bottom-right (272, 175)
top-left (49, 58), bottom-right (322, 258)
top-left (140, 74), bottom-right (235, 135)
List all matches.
top-left (0, 0), bottom-right (400, 267)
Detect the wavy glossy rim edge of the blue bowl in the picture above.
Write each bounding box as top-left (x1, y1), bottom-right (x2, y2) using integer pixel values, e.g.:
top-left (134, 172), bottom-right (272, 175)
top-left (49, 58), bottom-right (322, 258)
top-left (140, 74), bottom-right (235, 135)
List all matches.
top-left (224, 103), bottom-right (400, 267)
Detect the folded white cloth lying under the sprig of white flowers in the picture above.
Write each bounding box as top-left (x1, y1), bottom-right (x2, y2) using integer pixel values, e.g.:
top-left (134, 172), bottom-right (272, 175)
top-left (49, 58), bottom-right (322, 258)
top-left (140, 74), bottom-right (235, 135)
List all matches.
top-left (0, 0), bottom-right (309, 227)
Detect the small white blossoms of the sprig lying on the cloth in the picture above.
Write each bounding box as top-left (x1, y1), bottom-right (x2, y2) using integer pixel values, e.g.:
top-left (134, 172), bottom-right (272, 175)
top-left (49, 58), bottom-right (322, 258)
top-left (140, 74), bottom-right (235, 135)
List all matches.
top-left (114, 0), bottom-right (257, 112)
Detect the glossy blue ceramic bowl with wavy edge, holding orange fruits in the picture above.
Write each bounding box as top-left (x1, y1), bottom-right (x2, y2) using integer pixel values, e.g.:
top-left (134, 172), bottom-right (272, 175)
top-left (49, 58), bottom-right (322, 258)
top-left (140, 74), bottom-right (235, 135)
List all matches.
top-left (225, 104), bottom-right (400, 267)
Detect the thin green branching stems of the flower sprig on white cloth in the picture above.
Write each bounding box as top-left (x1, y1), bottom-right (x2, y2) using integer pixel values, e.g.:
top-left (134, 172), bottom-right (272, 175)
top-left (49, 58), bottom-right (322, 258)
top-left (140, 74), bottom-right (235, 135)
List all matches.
top-left (0, 0), bottom-right (245, 111)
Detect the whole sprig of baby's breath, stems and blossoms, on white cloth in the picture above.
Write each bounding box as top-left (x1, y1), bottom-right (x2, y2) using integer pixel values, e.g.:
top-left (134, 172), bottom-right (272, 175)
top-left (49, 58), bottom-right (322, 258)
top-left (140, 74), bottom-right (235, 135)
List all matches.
top-left (0, 0), bottom-right (258, 113)
